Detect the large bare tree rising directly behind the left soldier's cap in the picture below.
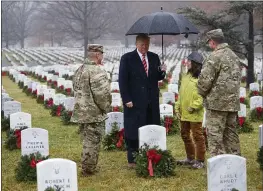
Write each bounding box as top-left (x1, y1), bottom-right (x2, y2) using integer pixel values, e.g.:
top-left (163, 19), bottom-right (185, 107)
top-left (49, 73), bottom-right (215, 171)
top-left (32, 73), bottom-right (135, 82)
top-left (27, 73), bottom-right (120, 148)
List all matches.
top-left (42, 1), bottom-right (117, 58)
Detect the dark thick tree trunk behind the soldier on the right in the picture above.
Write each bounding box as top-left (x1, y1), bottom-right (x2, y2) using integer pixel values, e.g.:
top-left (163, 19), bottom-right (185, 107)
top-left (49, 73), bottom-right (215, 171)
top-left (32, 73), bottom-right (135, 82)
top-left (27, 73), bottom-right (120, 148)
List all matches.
top-left (246, 10), bottom-right (255, 88)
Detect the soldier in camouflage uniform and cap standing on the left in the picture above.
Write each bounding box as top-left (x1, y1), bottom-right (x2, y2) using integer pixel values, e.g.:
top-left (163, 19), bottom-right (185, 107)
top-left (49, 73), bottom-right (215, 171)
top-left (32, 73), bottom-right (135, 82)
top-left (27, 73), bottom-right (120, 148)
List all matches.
top-left (71, 45), bottom-right (111, 176)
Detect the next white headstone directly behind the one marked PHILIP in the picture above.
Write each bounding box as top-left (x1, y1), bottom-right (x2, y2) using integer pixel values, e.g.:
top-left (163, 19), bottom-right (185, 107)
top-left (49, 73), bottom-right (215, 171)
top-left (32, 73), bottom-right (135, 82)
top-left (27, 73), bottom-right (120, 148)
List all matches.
top-left (10, 112), bottom-right (32, 129)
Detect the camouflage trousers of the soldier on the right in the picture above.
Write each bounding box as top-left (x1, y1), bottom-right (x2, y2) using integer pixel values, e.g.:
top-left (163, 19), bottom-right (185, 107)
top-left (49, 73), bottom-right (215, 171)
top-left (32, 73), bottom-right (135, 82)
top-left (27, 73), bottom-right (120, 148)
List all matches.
top-left (206, 109), bottom-right (241, 157)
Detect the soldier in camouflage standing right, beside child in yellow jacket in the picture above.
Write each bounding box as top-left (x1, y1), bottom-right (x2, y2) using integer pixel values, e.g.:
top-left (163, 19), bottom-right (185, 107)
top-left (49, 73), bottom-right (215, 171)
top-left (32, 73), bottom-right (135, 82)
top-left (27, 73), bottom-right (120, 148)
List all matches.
top-left (198, 29), bottom-right (241, 157)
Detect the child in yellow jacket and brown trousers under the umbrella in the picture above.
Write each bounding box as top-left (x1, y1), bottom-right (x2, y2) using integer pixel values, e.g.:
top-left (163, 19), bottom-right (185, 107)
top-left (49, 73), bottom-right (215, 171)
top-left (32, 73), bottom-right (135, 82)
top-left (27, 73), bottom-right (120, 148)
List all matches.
top-left (175, 52), bottom-right (206, 169)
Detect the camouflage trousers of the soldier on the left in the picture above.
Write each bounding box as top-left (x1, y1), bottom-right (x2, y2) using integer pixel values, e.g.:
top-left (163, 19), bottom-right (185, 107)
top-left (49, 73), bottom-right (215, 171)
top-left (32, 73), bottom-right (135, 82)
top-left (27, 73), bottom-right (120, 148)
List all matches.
top-left (80, 122), bottom-right (104, 174)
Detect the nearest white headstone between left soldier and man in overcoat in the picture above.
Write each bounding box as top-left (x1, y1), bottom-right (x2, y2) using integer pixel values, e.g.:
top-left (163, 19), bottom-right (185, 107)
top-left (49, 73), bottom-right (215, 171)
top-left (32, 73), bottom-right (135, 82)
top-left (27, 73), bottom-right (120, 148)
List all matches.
top-left (105, 112), bottom-right (124, 134)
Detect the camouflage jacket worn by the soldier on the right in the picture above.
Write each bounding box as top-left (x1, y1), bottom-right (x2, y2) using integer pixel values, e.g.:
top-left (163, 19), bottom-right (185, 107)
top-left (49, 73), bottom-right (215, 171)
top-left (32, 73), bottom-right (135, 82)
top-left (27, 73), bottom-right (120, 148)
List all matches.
top-left (197, 43), bottom-right (241, 112)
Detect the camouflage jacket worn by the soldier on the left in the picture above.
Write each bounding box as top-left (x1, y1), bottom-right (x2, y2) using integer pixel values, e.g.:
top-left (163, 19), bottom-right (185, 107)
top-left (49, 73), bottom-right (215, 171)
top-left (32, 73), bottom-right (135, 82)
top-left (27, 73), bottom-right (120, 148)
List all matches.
top-left (71, 59), bottom-right (111, 123)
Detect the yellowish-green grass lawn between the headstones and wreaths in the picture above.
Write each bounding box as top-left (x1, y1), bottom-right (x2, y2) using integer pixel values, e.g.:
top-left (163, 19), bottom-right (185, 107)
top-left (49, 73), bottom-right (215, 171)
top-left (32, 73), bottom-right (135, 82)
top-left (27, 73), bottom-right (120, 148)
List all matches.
top-left (1, 76), bottom-right (262, 191)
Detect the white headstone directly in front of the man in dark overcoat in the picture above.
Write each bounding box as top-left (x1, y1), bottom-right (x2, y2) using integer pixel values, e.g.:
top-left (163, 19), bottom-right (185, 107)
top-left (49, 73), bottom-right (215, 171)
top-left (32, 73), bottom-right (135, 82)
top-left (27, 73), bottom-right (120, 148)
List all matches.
top-left (139, 125), bottom-right (166, 150)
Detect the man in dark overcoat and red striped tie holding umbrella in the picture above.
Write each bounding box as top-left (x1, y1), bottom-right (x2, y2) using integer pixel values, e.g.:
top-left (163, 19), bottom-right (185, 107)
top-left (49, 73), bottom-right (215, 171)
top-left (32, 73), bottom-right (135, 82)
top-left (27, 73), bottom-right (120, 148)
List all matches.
top-left (119, 35), bottom-right (166, 167)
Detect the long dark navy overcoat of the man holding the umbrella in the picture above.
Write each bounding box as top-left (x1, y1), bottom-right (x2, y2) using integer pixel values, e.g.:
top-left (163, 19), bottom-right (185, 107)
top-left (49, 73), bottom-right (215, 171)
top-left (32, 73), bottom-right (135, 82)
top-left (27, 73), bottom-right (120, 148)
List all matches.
top-left (119, 49), bottom-right (165, 140)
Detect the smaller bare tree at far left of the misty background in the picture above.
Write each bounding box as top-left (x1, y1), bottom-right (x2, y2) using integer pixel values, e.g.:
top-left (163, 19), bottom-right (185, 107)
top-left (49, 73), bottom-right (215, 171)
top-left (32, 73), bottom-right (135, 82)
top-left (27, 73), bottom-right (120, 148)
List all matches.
top-left (11, 1), bottom-right (37, 48)
